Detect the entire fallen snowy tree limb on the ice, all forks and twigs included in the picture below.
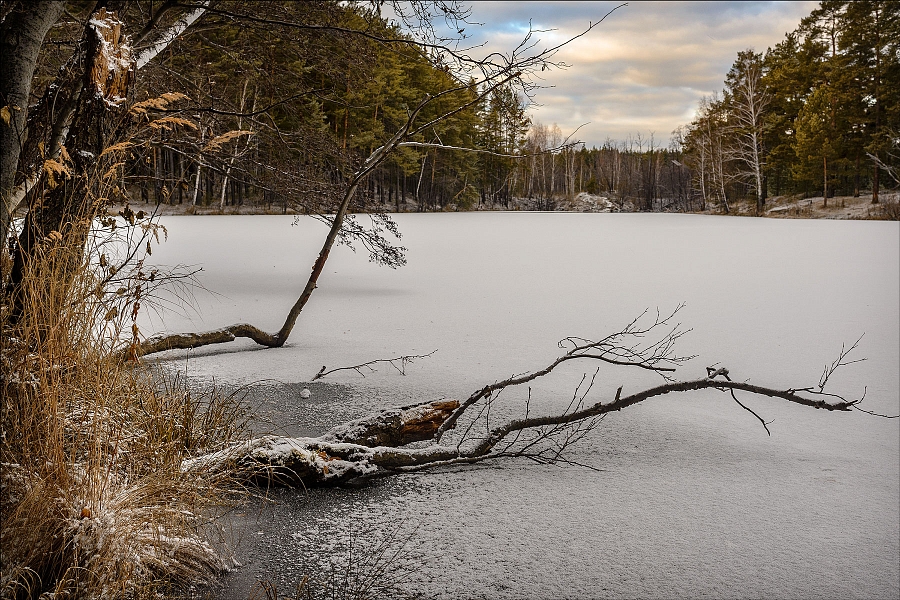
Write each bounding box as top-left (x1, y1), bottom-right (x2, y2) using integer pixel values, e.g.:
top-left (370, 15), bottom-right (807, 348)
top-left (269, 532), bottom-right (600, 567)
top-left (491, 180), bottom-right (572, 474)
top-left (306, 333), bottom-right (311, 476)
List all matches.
top-left (183, 306), bottom-right (896, 486)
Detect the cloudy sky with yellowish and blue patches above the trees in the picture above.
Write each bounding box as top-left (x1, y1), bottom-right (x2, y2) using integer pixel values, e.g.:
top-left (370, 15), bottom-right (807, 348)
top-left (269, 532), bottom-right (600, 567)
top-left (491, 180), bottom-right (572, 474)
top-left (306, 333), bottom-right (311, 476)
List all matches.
top-left (440, 2), bottom-right (818, 147)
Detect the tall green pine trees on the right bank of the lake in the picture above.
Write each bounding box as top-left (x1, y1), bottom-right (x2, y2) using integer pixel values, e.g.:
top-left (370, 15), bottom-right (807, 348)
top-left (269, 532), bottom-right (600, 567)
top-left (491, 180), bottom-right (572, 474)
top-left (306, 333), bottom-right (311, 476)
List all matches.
top-left (685, 0), bottom-right (900, 210)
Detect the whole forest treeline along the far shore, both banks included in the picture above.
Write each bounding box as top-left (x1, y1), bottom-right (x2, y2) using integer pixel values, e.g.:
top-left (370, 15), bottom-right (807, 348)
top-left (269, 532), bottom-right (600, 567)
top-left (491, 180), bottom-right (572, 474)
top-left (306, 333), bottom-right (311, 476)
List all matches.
top-left (130, 1), bottom-right (900, 212)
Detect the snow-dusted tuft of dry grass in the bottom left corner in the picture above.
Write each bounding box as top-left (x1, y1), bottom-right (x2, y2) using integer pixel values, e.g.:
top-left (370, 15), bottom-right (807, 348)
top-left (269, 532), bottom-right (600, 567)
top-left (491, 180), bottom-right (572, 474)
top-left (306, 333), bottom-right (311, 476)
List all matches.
top-left (0, 465), bottom-right (226, 598)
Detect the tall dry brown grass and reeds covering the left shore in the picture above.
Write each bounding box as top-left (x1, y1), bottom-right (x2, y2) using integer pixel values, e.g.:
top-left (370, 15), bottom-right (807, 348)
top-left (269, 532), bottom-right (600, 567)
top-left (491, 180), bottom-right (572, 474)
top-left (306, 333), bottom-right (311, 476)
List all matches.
top-left (0, 224), bottom-right (244, 599)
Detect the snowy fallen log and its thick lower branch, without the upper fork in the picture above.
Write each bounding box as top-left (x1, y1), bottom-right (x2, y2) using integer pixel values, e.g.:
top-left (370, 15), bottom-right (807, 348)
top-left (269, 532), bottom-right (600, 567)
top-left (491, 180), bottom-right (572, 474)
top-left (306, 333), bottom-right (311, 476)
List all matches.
top-left (183, 377), bottom-right (857, 486)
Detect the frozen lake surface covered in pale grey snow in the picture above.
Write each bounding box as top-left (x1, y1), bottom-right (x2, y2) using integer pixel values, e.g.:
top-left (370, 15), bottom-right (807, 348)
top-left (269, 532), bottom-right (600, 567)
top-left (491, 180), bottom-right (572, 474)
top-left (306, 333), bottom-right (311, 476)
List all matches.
top-left (142, 213), bottom-right (900, 598)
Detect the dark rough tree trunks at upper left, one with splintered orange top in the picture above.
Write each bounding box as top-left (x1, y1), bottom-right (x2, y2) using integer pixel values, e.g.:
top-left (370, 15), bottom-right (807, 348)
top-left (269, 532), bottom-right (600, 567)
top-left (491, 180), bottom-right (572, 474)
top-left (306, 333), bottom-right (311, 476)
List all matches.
top-left (0, 2), bottom-right (207, 322)
